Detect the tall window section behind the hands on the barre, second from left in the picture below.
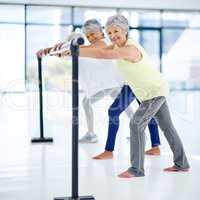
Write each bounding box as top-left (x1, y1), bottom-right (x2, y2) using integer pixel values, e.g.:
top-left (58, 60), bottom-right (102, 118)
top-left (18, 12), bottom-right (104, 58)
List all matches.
top-left (26, 6), bottom-right (73, 90)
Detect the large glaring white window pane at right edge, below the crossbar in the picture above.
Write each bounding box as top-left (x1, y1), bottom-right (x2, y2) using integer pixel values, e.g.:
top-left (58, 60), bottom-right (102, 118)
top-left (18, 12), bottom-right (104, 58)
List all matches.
top-left (162, 29), bottom-right (200, 89)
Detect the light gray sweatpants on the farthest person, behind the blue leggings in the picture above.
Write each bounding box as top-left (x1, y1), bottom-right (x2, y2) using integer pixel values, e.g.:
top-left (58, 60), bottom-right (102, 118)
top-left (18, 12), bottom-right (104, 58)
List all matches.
top-left (82, 87), bottom-right (133, 132)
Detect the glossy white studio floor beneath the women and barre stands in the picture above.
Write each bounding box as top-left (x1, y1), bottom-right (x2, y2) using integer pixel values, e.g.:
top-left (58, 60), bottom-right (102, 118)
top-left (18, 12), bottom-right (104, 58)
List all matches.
top-left (0, 92), bottom-right (200, 200)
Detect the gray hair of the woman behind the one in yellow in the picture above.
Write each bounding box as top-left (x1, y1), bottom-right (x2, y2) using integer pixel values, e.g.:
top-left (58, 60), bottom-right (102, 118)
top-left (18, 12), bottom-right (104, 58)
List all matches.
top-left (82, 19), bottom-right (103, 34)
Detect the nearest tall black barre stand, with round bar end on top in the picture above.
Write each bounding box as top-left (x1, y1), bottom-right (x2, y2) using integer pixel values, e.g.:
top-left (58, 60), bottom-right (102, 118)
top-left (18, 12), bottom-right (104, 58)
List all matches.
top-left (54, 37), bottom-right (95, 200)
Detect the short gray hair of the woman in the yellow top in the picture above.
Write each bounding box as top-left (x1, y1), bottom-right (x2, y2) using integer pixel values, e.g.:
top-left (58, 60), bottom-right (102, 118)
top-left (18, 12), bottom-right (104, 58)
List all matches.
top-left (105, 14), bottom-right (129, 33)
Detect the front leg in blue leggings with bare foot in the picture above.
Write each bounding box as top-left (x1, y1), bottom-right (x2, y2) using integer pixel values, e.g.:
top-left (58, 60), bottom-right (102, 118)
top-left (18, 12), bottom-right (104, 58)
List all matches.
top-left (94, 85), bottom-right (135, 159)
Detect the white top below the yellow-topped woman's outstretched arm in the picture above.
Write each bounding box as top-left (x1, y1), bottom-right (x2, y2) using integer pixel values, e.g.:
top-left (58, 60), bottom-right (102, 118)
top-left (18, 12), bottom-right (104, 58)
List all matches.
top-left (79, 57), bottom-right (125, 97)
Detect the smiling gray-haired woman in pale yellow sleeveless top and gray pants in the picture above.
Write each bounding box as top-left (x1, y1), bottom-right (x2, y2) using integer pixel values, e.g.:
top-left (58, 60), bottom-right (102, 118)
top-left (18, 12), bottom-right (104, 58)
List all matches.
top-left (61, 15), bottom-right (190, 178)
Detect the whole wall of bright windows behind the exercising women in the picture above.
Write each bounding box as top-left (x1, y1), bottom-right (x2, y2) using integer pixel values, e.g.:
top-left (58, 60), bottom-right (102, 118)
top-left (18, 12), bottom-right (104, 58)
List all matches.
top-left (0, 4), bottom-right (200, 91)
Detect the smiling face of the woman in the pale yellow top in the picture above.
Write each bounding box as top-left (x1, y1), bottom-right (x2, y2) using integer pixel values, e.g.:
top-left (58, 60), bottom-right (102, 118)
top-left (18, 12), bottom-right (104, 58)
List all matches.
top-left (106, 25), bottom-right (127, 47)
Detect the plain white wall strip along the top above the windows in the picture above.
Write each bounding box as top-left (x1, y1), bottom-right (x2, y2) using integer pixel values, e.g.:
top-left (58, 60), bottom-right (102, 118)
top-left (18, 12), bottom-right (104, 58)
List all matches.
top-left (0, 0), bottom-right (200, 10)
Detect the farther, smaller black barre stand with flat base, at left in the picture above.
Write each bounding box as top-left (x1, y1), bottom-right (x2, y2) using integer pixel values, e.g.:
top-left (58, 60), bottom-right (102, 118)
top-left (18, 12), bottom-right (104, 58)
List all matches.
top-left (31, 57), bottom-right (53, 143)
